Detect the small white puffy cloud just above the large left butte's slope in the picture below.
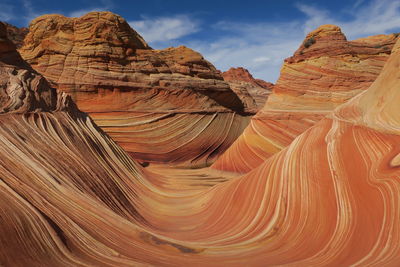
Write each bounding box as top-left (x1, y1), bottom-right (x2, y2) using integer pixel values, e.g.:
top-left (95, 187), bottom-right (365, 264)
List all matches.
top-left (129, 15), bottom-right (199, 43)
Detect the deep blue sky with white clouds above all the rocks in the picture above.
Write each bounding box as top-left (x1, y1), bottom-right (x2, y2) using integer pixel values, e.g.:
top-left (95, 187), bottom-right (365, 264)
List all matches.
top-left (0, 0), bottom-right (400, 82)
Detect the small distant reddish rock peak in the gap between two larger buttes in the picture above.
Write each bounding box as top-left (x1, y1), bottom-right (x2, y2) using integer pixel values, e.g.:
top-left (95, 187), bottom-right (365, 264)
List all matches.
top-left (222, 67), bottom-right (274, 110)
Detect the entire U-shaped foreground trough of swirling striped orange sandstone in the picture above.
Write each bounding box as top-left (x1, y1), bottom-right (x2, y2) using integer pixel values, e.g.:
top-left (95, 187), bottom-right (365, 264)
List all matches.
top-left (0, 16), bottom-right (400, 266)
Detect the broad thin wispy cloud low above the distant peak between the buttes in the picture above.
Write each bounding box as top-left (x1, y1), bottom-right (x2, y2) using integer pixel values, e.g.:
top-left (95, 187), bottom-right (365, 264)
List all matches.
top-left (187, 21), bottom-right (303, 81)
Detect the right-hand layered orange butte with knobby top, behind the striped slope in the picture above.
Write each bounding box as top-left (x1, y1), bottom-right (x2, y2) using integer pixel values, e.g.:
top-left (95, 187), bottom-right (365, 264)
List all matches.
top-left (212, 25), bottom-right (397, 173)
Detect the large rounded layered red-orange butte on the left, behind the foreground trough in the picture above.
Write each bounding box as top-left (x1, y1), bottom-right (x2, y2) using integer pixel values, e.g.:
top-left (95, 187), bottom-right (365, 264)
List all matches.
top-left (19, 12), bottom-right (256, 166)
